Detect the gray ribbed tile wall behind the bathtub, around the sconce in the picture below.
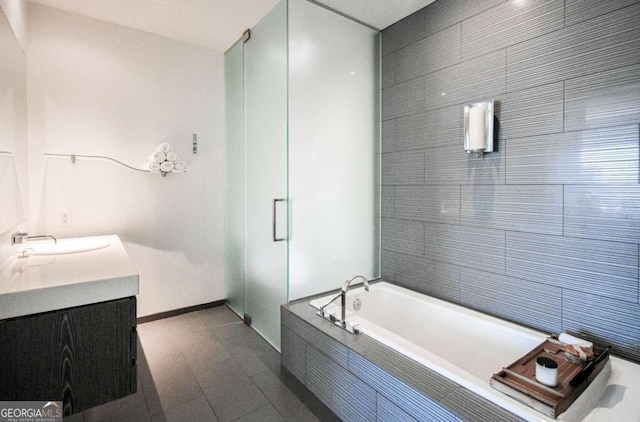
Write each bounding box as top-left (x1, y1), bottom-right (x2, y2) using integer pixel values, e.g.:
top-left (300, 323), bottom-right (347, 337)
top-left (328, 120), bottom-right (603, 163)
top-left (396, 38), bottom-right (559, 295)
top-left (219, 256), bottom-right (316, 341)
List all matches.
top-left (382, 0), bottom-right (640, 361)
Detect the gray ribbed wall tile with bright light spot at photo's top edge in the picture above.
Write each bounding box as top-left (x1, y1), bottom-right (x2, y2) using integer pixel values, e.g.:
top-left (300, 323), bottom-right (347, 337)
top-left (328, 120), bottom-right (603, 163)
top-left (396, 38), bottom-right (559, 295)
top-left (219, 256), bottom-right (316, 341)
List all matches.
top-left (462, 0), bottom-right (564, 60)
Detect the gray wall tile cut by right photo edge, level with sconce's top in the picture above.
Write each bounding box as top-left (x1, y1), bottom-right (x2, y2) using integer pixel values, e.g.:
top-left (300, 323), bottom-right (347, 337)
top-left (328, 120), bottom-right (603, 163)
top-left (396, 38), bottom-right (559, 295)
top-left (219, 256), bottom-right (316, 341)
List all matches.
top-left (564, 64), bottom-right (640, 131)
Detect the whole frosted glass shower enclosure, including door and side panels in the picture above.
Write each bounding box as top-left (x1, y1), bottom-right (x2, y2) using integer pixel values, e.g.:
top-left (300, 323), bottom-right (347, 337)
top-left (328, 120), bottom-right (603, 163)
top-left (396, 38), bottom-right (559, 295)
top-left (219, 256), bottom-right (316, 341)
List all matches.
top-left (225, 0), bottom-right (380, 350)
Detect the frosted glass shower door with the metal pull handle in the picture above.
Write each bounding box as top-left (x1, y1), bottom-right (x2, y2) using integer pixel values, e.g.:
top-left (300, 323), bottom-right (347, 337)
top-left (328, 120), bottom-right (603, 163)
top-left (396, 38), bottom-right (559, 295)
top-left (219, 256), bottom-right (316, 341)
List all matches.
top-left (244, 1), bottom-right (287, 350)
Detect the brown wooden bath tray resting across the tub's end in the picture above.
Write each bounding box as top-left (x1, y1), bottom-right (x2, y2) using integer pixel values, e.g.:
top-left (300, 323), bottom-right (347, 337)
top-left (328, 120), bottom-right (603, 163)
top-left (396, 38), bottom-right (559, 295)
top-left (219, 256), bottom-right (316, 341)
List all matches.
top-left (490, 336), bottom-right (609, 419)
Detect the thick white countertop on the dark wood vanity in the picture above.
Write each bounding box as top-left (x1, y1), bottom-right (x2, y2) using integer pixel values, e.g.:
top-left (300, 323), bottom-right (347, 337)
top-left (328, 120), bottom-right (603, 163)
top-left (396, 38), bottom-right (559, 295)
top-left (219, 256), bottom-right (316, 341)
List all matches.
top-left (0, 235), bottom-right (138, 319)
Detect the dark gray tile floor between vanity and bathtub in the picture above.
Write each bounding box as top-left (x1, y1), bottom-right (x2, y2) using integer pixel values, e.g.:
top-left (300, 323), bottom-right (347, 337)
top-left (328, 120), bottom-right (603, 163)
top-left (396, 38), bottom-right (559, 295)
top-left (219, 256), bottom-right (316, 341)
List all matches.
top-left (64, 306), bottom-right (339, 422)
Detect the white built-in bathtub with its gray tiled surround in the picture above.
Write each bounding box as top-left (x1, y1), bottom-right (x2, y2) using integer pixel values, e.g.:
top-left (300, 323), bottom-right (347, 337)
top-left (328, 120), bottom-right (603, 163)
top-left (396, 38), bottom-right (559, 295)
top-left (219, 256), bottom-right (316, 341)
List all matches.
top-left (281, 283), bottom-right (640, 422)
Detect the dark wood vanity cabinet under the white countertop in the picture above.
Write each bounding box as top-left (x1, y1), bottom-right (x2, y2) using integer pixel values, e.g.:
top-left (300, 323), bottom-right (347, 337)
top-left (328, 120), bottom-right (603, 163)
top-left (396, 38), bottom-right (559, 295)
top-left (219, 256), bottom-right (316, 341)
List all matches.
top-left (0, 296), bottom-right (137, 415)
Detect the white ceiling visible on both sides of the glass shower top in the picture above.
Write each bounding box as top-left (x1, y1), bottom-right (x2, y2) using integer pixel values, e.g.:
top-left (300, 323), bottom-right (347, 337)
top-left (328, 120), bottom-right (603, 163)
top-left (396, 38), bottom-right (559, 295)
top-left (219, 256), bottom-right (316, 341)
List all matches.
top-left (30, 0), bottom-right (434, 52)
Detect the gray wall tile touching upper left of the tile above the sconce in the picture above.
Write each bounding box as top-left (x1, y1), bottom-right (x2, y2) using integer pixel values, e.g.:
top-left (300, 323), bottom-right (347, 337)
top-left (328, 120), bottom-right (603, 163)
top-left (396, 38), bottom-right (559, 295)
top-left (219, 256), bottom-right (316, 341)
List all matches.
top-left (394, 24), bottom-right (460, 82)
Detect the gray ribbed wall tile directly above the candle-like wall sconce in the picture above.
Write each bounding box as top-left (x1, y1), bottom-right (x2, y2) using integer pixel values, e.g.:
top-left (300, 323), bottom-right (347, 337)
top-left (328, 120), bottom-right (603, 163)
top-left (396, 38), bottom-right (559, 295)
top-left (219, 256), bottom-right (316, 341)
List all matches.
top-left (422, 50), bottom-right (506, 110)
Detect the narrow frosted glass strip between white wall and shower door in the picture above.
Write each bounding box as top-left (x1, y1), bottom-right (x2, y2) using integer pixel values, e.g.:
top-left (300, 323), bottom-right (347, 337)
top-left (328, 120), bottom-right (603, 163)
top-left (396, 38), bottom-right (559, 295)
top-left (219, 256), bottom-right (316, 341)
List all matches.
top-left (224, 41), bottom-right (244, 315)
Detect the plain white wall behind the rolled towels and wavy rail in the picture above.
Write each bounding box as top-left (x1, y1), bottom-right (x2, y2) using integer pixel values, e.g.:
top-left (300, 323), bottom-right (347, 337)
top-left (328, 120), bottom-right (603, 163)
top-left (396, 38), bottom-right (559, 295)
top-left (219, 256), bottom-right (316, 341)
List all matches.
top-left (27, 4), bottom-right (225, 316)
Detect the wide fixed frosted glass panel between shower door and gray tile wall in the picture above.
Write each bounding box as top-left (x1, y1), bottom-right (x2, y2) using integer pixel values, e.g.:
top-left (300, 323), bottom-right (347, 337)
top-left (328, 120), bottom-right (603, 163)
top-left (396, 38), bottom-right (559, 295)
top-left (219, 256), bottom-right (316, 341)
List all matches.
top-left (289, 0), bottom-right (379, 300)
